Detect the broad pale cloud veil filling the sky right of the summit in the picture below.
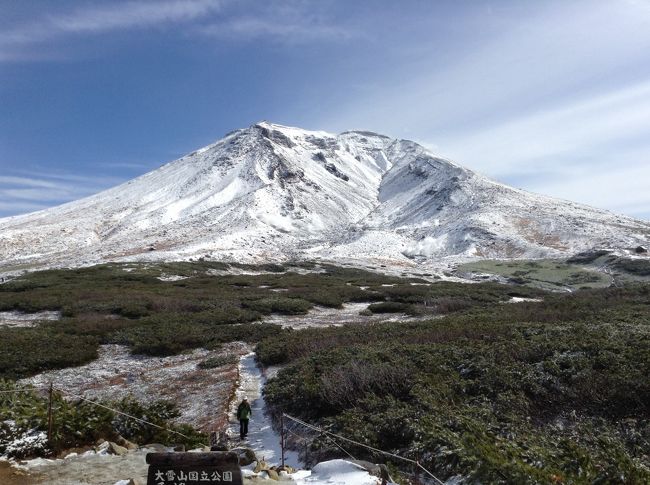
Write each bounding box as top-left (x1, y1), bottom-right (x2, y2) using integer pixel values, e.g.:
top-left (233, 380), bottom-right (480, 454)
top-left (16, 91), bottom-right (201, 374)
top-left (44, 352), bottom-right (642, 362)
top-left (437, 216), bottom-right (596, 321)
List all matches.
top-left (320, 0), bottom-right (650, 217)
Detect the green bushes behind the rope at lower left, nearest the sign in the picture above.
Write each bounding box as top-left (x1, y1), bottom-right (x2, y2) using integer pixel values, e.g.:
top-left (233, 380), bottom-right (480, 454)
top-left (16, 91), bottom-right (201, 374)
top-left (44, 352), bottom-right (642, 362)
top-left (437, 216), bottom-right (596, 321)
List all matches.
top-left (0, 380), bottom-right (207, 458)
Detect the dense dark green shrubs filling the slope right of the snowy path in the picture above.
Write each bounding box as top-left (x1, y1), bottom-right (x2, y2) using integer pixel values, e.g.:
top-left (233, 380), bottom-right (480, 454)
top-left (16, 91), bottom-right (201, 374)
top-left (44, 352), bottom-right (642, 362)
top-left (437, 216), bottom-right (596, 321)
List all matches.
top-left (257, 285), bottom-right (650, 484)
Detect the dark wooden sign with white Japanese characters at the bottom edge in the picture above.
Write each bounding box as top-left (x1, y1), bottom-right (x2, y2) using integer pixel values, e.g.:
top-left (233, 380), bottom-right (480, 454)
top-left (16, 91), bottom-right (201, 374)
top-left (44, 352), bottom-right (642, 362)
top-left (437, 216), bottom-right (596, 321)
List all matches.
top-left (146, 451), bottom-right (243, 485)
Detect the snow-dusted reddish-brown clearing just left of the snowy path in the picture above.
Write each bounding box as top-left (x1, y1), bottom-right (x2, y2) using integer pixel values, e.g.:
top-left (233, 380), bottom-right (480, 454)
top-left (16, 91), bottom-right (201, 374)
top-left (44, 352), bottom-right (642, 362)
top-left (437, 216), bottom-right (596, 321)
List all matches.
top-left (20, 344), bottom-right (249, 431)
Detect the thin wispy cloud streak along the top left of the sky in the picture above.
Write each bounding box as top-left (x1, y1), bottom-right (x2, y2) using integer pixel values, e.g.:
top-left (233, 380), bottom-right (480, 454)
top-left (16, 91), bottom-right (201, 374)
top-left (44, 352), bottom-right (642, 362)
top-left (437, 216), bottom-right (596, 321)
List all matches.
top-left (0, 0), bottom-right (358, 61)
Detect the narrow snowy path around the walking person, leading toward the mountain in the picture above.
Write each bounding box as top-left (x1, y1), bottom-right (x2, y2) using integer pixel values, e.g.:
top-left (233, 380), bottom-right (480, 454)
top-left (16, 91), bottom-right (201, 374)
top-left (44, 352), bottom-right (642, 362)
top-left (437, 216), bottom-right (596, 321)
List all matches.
top-left (228, 353), bottom-right (302, 467)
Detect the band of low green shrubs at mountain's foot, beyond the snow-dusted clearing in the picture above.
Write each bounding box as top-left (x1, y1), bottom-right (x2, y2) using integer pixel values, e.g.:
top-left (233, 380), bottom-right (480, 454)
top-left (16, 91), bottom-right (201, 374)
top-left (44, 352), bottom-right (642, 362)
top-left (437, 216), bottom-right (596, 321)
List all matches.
top-left (0, 261), bottom-right (537, 379)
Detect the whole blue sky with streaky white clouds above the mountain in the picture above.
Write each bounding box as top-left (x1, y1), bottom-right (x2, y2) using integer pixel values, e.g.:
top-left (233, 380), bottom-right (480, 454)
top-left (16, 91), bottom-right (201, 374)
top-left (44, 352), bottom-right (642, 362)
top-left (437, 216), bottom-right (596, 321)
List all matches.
top-left (0, 0), bottom-right (650, 219)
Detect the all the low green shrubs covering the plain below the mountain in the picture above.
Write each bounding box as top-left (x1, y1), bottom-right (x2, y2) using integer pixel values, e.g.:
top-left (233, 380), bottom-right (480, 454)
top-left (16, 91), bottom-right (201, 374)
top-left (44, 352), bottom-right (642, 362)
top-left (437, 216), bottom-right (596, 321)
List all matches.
top-left (0, 260), bottom-right (650, 483)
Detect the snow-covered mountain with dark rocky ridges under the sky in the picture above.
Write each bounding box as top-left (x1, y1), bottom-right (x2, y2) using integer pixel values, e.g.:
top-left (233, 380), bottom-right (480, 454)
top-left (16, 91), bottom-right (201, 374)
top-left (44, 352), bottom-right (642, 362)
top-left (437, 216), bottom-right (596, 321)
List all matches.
top-left (0, 122), bottom-right (650, 273)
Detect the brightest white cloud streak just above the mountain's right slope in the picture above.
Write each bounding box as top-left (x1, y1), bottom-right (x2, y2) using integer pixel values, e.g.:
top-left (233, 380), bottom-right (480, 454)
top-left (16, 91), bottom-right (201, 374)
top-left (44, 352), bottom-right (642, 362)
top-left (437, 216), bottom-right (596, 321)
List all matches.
top-left (437, 82), bottom-right (650, 176)
